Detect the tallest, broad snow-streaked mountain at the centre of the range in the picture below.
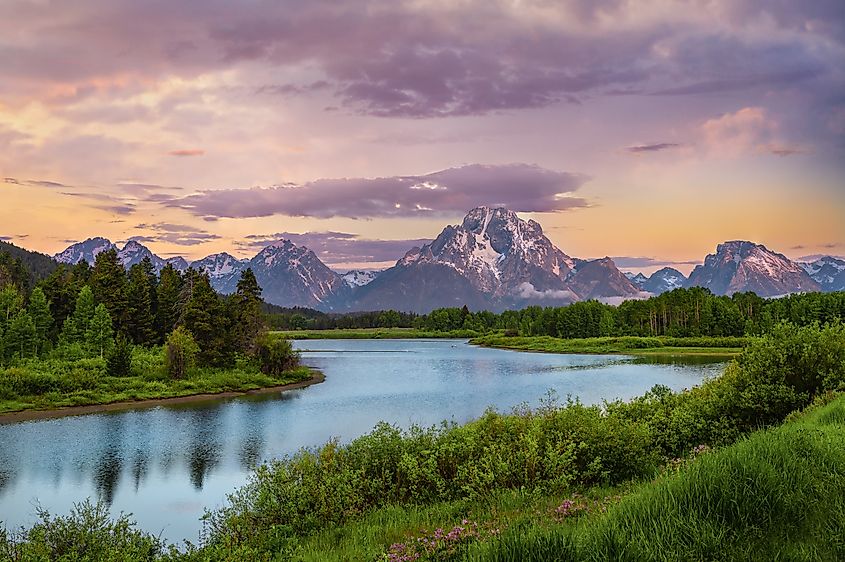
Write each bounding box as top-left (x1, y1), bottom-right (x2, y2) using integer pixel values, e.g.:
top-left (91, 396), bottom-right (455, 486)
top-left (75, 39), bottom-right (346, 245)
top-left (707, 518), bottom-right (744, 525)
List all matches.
top-left (349, 207), bottom-right (639, 312)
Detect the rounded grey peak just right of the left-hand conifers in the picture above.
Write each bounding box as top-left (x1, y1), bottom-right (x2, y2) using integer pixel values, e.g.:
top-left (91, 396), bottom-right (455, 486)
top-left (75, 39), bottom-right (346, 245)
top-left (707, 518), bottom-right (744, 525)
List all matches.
top-left (247, 240), bottom-right (352, 310)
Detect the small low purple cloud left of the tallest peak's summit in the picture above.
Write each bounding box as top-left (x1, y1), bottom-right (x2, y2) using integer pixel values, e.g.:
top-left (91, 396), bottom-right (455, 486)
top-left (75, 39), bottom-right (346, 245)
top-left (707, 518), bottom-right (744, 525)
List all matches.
top-left (235, 232), bottom-right (431, 265)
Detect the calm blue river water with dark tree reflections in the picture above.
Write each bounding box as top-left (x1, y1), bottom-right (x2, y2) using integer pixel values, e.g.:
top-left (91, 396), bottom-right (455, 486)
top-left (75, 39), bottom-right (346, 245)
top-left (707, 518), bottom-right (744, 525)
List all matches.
top-left (0, 340), bottom-right (722, 542)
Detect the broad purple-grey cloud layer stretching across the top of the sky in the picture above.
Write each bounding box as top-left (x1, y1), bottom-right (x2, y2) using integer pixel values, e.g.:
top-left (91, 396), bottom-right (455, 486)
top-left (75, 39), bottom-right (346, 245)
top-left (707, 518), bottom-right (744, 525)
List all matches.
top-left (0, 0), bottom-right (845, 120)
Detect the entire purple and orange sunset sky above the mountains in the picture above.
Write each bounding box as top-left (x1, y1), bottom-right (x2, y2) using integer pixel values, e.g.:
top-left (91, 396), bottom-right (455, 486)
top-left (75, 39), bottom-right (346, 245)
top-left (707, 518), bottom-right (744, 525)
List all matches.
top-left (0, 0), bottom-right (845, 273)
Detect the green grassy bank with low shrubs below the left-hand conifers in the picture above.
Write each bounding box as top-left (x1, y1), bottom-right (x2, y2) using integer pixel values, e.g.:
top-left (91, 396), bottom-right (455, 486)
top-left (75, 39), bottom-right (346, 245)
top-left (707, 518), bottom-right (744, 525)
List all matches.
top-left (0, 347), bottom-right (312, 414)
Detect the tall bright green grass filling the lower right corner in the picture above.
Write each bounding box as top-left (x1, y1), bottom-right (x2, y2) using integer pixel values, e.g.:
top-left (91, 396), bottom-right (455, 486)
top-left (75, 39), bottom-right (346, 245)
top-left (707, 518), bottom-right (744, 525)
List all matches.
top-left (465, 397), bottom-right (845, 562)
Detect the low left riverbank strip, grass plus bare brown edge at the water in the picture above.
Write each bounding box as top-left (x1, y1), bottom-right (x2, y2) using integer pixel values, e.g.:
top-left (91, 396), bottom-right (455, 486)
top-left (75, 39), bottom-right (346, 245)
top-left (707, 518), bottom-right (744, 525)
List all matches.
top-left (0, 367), bottom-right (325, 424)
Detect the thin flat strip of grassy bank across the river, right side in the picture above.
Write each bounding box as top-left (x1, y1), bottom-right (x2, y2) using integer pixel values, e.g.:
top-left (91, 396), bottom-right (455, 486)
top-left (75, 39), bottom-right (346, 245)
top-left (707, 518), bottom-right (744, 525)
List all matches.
top-left (470, 334), bottom-right (748, 356)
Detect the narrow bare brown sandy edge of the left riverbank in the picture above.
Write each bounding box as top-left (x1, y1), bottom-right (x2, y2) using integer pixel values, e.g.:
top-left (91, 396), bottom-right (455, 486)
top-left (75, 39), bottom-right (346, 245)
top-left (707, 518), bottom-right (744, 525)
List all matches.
top-left (0, 370), bottom-right (326, 424)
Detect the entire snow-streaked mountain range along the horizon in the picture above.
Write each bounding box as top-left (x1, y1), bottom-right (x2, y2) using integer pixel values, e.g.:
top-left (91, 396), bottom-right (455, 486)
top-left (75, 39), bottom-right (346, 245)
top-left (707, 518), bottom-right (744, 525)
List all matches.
top-left (47, 207), bottom-right (845, 312)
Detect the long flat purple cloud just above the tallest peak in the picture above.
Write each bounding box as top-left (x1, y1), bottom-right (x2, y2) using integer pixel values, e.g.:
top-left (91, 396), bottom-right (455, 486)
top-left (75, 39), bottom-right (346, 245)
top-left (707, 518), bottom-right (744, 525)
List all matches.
top-left (165, 164), bottom-right (588, 218)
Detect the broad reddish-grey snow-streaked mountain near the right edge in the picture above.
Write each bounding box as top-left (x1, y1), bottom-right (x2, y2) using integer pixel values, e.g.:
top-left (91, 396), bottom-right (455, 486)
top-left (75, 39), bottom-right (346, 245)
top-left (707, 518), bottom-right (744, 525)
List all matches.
top-left (687, 240), bottom-right (820, 297)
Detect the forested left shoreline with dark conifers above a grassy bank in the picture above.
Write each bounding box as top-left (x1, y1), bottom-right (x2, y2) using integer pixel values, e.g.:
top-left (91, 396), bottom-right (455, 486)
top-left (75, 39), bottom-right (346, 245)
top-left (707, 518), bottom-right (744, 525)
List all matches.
top-left (0, 250), bottom-right (304, 412)
